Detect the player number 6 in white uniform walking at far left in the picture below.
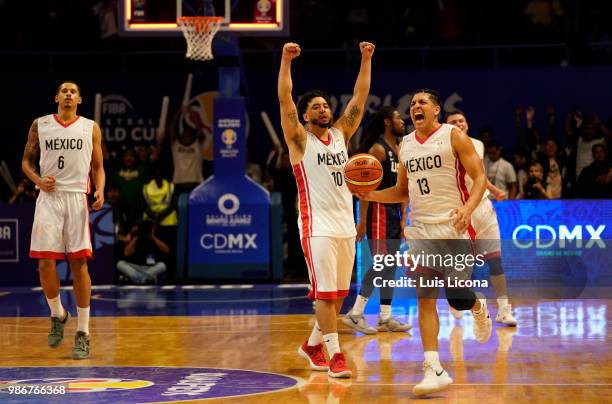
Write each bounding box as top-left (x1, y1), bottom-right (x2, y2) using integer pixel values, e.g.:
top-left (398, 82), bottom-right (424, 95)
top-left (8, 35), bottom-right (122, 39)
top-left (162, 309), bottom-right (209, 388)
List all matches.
top-left (21, 81), bottom-right (106, 359)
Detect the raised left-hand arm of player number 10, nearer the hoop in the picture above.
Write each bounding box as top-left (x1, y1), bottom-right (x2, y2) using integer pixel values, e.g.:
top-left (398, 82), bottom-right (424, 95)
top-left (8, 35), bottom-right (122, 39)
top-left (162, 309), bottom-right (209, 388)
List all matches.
top-left (278, 42), bottom-right (306, 164)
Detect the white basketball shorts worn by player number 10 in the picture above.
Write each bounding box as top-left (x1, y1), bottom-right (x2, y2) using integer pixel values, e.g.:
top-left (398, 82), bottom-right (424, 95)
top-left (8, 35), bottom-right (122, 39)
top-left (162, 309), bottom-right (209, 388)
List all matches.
top-left (302, 237), bottom-right (355, 300)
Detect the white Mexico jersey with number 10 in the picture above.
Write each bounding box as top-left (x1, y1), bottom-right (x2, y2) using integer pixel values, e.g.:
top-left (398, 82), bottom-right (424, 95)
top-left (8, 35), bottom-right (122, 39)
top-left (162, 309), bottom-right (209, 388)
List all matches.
top-left (293, 128), bottom-right (357, 238)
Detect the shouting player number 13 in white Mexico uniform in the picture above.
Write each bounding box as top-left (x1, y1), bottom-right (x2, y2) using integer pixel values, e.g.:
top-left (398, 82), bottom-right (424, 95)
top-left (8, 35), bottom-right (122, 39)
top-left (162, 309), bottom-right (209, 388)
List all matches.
top-left (359, 90), bottom-right (491, 396)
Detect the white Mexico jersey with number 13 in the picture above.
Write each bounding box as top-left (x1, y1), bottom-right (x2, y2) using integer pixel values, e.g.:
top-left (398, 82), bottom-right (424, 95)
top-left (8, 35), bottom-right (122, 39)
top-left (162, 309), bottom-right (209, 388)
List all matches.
top-left (399, 123), bottom-right (469, 223)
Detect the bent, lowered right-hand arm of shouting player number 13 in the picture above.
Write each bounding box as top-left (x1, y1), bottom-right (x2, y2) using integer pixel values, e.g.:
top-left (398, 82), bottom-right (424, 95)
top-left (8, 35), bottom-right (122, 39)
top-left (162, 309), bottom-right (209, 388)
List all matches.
top-left (451, 129), bottom-right (487, 233)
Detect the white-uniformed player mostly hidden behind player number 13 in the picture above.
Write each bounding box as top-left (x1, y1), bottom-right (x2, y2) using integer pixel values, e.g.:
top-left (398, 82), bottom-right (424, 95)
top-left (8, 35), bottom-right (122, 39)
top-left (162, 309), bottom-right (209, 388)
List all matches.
top-left (446, 110), bottom-right (516, 327)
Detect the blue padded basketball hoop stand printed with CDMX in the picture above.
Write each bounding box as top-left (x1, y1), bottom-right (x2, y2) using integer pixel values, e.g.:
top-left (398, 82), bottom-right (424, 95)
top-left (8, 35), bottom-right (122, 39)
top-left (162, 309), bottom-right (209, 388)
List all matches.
top-left (188, 97), bottom-right (270, 279)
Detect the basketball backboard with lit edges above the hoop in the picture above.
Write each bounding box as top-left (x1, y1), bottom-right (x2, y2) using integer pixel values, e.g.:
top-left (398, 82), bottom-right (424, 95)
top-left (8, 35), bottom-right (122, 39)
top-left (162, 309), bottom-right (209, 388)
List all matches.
top-left (119, 0), bottom-right (289, 36)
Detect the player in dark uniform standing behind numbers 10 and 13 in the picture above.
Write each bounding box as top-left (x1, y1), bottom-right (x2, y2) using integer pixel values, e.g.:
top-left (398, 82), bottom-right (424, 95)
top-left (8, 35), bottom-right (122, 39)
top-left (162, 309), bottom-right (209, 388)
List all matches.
top-left (342, 106), bottom-right (411, 334)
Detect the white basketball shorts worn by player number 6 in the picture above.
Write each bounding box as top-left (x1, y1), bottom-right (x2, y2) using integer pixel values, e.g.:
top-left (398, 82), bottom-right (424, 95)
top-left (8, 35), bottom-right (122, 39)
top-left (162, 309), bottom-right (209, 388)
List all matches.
top-left (30, 191), bottom-right (93, 259)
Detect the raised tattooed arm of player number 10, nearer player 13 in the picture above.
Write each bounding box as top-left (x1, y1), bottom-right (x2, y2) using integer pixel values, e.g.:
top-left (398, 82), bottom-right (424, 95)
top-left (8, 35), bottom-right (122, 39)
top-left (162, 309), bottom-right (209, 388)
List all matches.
top-left (334, 42), bottom-right (375, 142)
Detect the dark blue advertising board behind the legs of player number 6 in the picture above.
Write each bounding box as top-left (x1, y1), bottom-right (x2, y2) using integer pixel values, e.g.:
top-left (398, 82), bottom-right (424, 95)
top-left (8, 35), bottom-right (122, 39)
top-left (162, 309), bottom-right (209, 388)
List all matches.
top-left (0, 204), bottom-right (115, 286)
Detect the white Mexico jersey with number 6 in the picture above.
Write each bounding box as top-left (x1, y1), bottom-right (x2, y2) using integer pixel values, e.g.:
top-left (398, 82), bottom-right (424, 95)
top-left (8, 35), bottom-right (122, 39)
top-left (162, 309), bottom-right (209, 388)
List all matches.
top-left (38, 115), bottom-right (94, 193)
